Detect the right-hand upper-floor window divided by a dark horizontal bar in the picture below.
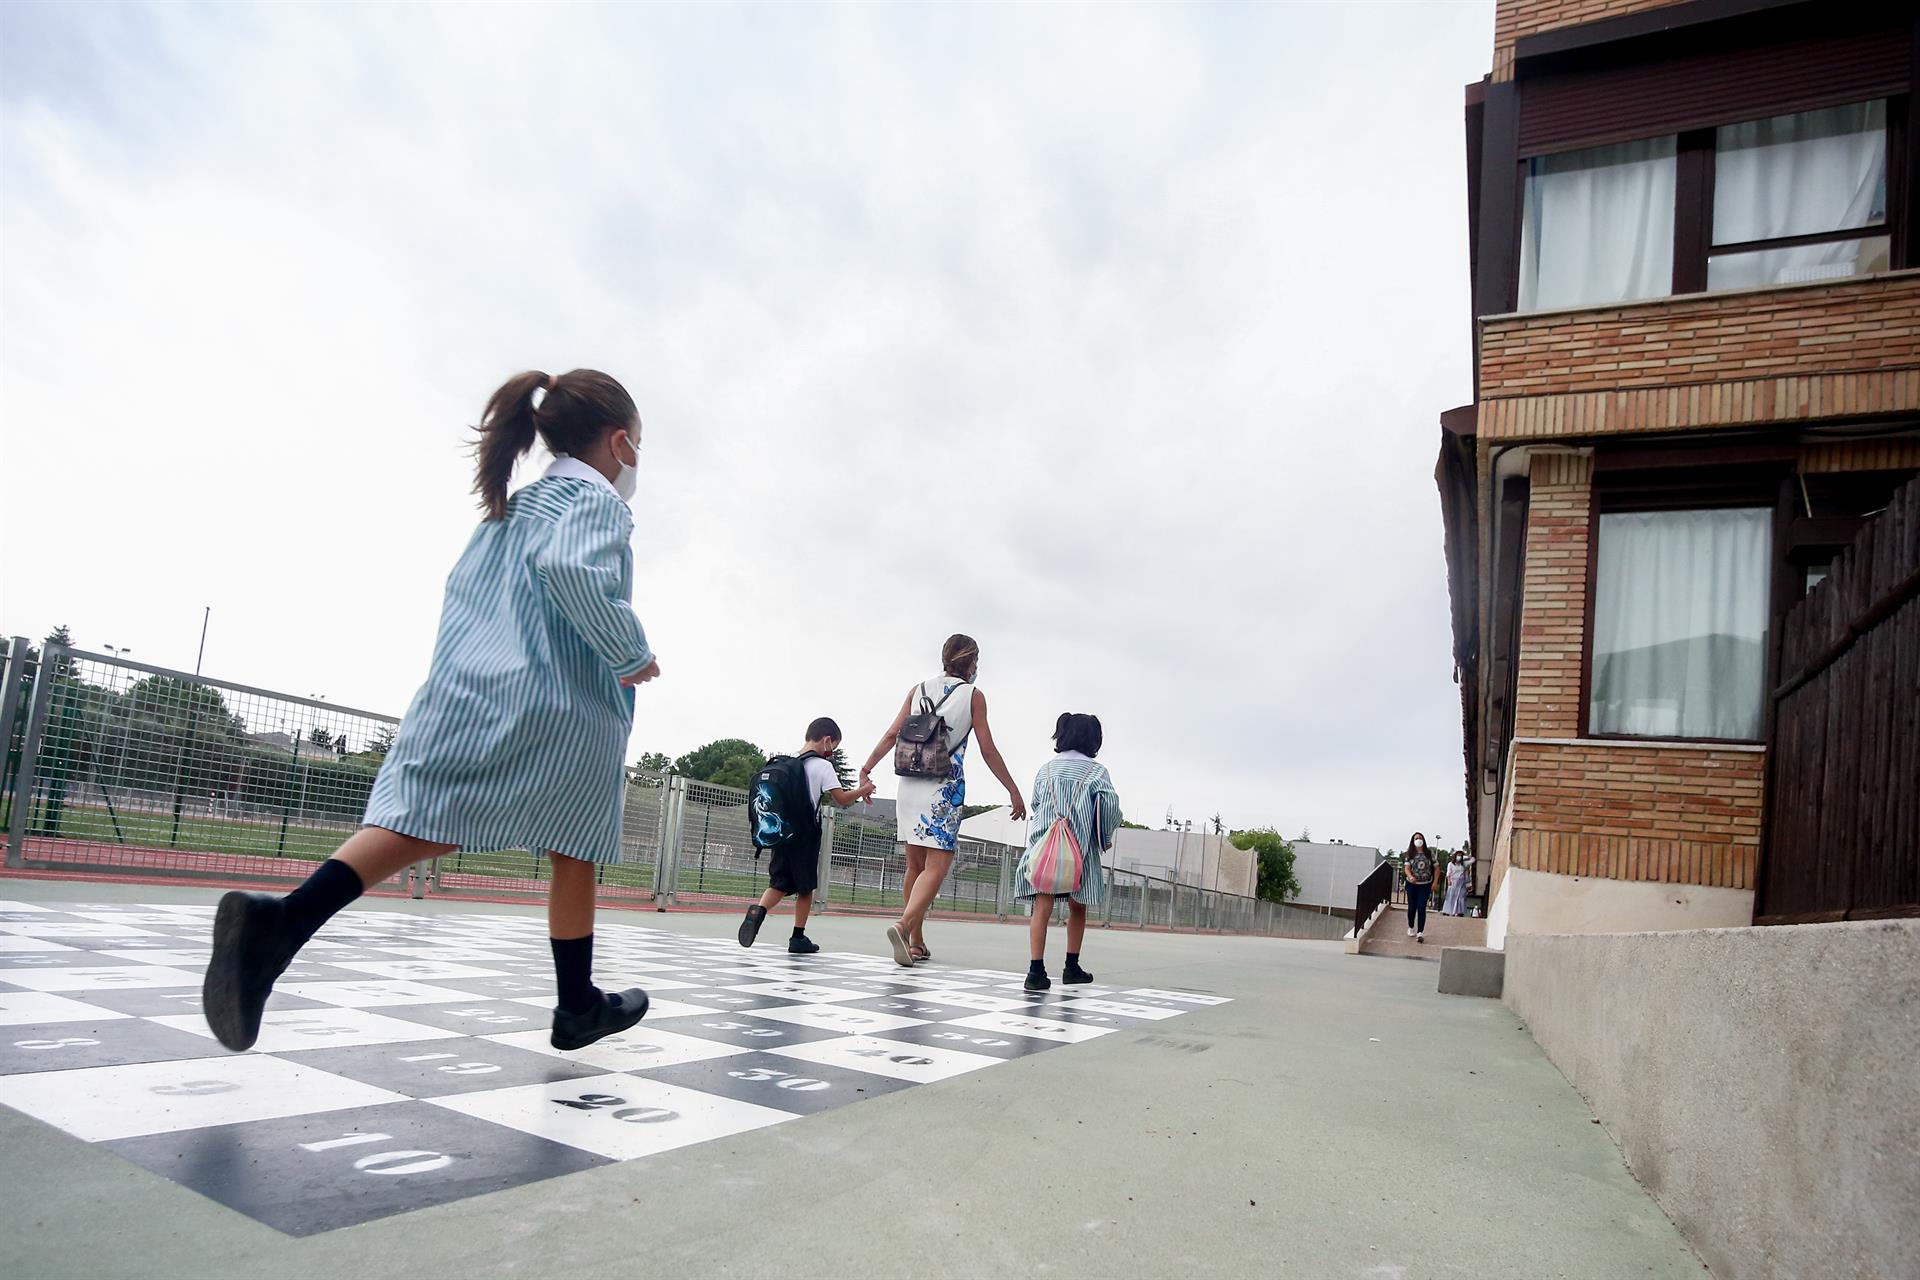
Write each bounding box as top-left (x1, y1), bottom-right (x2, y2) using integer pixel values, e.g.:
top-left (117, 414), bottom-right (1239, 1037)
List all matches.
top-left (1707, 102), bottom-right (1891, 290)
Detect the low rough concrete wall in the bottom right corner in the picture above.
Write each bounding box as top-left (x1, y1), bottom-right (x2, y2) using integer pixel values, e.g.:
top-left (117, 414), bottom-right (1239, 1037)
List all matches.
top-left (1505, 919), bottom-right (1920, 1280)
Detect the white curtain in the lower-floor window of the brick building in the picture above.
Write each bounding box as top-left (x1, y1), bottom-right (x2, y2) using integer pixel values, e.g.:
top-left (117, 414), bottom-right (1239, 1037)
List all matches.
top-left (1588, 509), bottom-right (1772, 739)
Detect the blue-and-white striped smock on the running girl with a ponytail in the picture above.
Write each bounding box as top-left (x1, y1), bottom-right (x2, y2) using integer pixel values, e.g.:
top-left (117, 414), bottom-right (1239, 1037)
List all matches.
top-left (365, 457), bottom-right (653, 862)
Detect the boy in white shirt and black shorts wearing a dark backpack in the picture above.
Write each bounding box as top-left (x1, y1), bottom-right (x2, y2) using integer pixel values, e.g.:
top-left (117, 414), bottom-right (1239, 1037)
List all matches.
top-left (739, 716), bottom-right (874, 956)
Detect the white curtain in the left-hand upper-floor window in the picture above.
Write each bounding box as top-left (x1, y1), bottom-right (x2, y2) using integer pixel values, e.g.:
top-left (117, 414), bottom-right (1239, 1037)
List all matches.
top-left (1521, 136), bottom-right (1674, 311)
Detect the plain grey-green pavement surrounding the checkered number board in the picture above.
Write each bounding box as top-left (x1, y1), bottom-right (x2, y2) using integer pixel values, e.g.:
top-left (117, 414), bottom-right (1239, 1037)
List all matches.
top-left (0, 879), bottom-right (1705, 1280)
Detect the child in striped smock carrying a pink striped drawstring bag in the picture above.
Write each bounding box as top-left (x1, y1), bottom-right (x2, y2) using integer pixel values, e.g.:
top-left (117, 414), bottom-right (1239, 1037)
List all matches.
top-left (1016, 712), bottom-right (1119, 990)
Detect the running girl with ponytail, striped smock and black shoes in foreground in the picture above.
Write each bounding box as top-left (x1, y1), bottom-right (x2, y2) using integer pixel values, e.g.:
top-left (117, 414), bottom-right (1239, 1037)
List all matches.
top-left (202, 368), bottom-right (660, 1052)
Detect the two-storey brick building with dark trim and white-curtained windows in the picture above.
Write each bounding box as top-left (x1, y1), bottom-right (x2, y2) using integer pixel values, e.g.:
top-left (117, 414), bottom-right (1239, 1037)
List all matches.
top-left (1436, 0), bottom-right (1920, 946)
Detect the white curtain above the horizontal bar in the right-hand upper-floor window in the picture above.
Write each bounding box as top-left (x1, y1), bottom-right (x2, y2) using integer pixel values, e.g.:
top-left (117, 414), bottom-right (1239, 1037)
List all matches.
top-left (1713, 102), bottom-right (1887, 244)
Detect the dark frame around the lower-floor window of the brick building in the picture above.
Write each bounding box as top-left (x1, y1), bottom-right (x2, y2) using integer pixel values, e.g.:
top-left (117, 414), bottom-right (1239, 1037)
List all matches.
top-left (1578, 466), bottom-right (1782, 747)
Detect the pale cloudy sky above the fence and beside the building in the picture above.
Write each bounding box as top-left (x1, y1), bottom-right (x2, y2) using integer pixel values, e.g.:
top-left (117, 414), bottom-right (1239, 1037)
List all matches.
top-left (0, 2), bottom-right (1492, 844)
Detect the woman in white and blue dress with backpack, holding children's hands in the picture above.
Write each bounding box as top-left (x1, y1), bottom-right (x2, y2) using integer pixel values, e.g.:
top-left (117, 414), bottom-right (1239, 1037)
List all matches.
top-left (860, 635), bottom-right (1027, 967)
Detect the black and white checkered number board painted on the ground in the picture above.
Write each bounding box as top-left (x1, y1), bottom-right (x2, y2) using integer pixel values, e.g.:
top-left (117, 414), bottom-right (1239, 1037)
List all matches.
top-left (0, 900), bottom-right (1227, 1236)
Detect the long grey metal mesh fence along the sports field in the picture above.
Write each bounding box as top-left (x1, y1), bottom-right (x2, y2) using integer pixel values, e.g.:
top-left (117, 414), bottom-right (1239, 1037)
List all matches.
top-left (0, 637), bottom-right (1348, 938)
